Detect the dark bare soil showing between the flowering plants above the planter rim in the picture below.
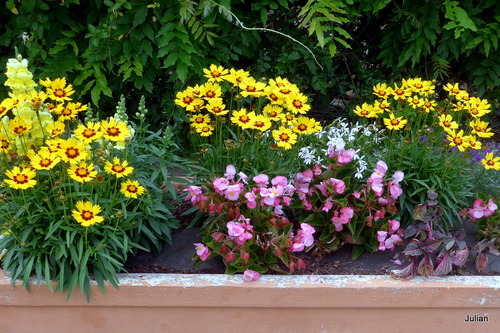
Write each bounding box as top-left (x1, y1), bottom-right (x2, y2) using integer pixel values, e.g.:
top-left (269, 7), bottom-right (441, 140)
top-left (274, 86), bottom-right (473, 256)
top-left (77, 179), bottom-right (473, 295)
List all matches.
top-left (125, 200), bottom-right (500, 275)
